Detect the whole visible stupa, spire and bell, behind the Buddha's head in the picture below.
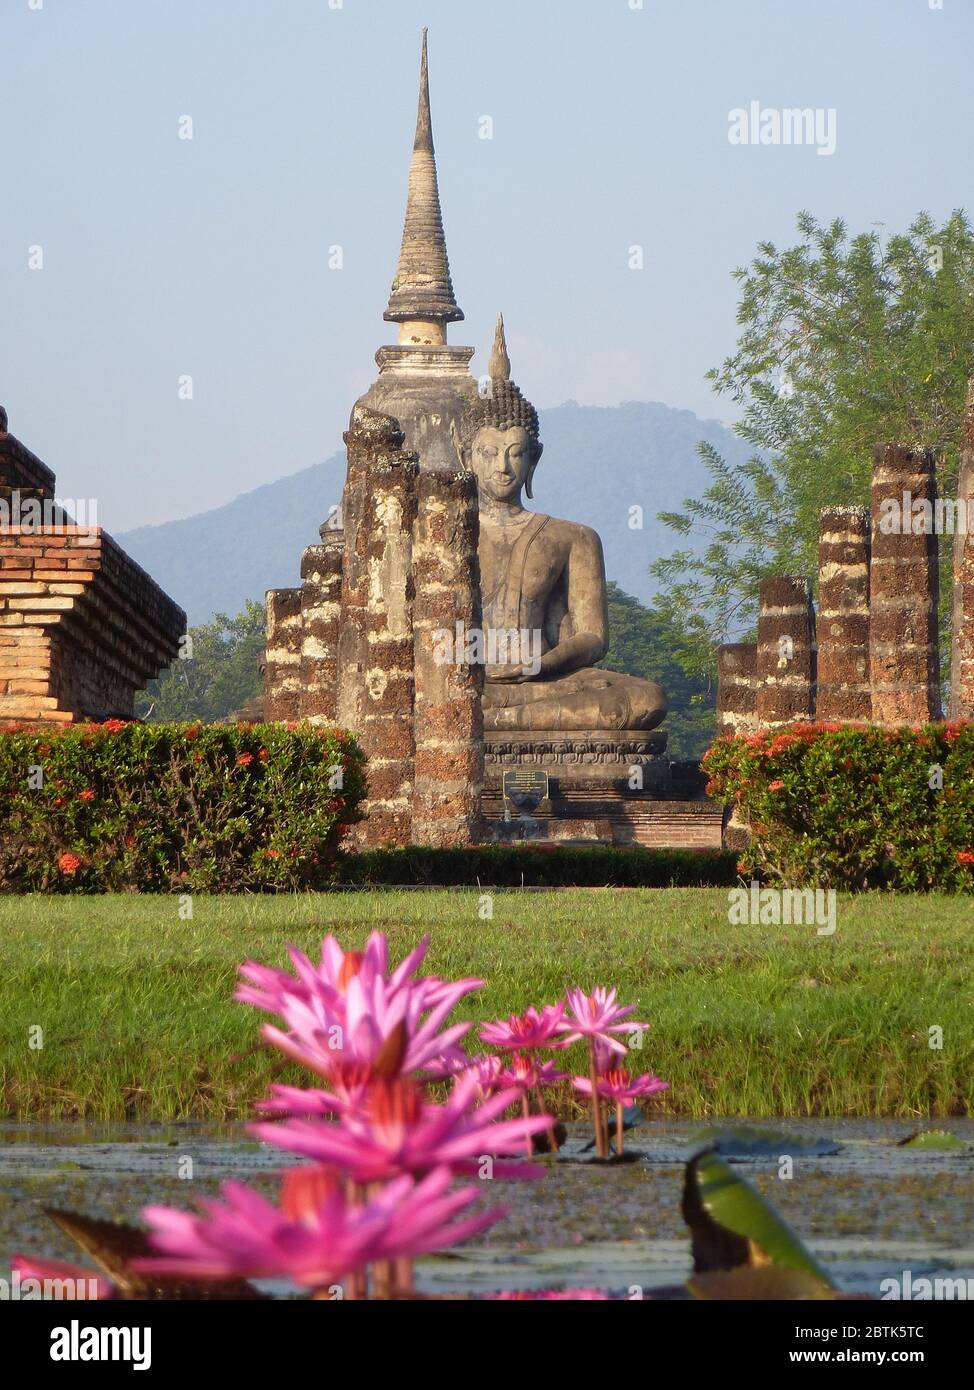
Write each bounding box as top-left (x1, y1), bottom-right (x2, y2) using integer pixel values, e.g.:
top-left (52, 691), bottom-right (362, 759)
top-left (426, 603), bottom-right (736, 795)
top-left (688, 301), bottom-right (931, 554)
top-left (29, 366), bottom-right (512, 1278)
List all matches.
top-left (356, 29), bottom-right (478, 470)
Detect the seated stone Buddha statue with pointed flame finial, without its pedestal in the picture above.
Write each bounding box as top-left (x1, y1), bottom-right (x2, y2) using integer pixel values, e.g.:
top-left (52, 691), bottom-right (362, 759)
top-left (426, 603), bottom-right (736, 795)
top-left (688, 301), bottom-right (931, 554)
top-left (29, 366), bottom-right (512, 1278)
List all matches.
top-left (470, 318), bottom-right (667, 733)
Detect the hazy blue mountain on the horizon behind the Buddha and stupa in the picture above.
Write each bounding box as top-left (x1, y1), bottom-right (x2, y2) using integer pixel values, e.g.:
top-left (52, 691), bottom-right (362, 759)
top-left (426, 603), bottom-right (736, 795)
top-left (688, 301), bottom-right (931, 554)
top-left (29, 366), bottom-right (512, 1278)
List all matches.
top-left (117, 402), bottom-right (749, 624)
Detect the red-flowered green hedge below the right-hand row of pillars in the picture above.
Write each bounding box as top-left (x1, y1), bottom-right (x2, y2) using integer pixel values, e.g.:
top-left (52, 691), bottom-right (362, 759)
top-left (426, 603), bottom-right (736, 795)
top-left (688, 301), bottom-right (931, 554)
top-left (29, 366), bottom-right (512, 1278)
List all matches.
top-left (703, 721), bottom-right (974, 892)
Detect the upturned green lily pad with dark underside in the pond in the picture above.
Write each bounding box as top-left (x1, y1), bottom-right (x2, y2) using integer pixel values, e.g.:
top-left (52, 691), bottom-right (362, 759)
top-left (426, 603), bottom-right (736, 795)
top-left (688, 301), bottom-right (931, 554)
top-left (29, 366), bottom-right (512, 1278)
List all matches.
top-left (682, 1150), bottom-right (832, 1289)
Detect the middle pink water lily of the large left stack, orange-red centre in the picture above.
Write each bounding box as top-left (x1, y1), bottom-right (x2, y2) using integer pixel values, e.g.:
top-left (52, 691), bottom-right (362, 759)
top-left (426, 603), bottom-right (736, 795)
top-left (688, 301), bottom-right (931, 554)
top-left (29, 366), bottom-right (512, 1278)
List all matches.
top-left (247, 1076), bottom-right (553, 1183)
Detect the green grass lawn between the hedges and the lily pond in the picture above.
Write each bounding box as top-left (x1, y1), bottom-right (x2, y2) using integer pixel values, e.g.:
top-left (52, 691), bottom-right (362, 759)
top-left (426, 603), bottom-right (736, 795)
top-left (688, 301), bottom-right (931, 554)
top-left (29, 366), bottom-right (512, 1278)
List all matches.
top-left (0, 888), bottom-right (974, 1119)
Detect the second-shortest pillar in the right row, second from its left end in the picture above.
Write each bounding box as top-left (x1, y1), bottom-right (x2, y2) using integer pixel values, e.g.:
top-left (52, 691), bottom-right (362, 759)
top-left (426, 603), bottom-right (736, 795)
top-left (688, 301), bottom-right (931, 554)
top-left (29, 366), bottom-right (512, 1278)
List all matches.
top-left (756, 574), bottom-right (816, 728)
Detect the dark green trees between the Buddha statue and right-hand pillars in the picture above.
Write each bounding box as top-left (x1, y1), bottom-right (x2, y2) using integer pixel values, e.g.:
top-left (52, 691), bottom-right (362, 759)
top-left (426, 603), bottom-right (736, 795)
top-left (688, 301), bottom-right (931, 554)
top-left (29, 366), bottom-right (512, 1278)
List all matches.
top-left (603, 582), bottom-right (716, 758)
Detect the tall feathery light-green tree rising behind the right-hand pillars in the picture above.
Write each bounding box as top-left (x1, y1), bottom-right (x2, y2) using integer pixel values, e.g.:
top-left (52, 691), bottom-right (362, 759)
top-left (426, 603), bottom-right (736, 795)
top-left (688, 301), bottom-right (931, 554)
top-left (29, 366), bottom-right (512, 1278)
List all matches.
top-left (650, 211), bottom-right (974, 673)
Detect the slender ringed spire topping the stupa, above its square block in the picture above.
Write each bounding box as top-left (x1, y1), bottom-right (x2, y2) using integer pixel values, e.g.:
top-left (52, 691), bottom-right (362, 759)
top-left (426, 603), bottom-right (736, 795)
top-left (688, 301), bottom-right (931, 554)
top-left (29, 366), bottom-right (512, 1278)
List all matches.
top-left (382, 29), bottom-right (463, 346)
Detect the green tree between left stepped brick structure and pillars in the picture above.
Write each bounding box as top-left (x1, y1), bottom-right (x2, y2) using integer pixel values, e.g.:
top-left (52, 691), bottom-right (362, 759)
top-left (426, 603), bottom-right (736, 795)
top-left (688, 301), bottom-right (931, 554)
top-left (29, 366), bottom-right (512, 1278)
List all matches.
top-left (135, 599), bottom-right (265, 724)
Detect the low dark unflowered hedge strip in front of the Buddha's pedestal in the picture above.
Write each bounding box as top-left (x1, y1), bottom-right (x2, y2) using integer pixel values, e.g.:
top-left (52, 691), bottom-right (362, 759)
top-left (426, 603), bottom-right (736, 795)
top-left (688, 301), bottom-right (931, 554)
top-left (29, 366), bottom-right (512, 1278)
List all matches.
top-left (330, 841), bottom-right (736, 888)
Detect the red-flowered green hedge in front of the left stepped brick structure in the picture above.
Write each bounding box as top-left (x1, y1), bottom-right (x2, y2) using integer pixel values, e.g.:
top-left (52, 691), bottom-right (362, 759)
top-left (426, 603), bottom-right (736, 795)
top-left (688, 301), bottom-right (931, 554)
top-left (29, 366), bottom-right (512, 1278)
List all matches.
top-left (0, 720), bottom-right (365, 892)
